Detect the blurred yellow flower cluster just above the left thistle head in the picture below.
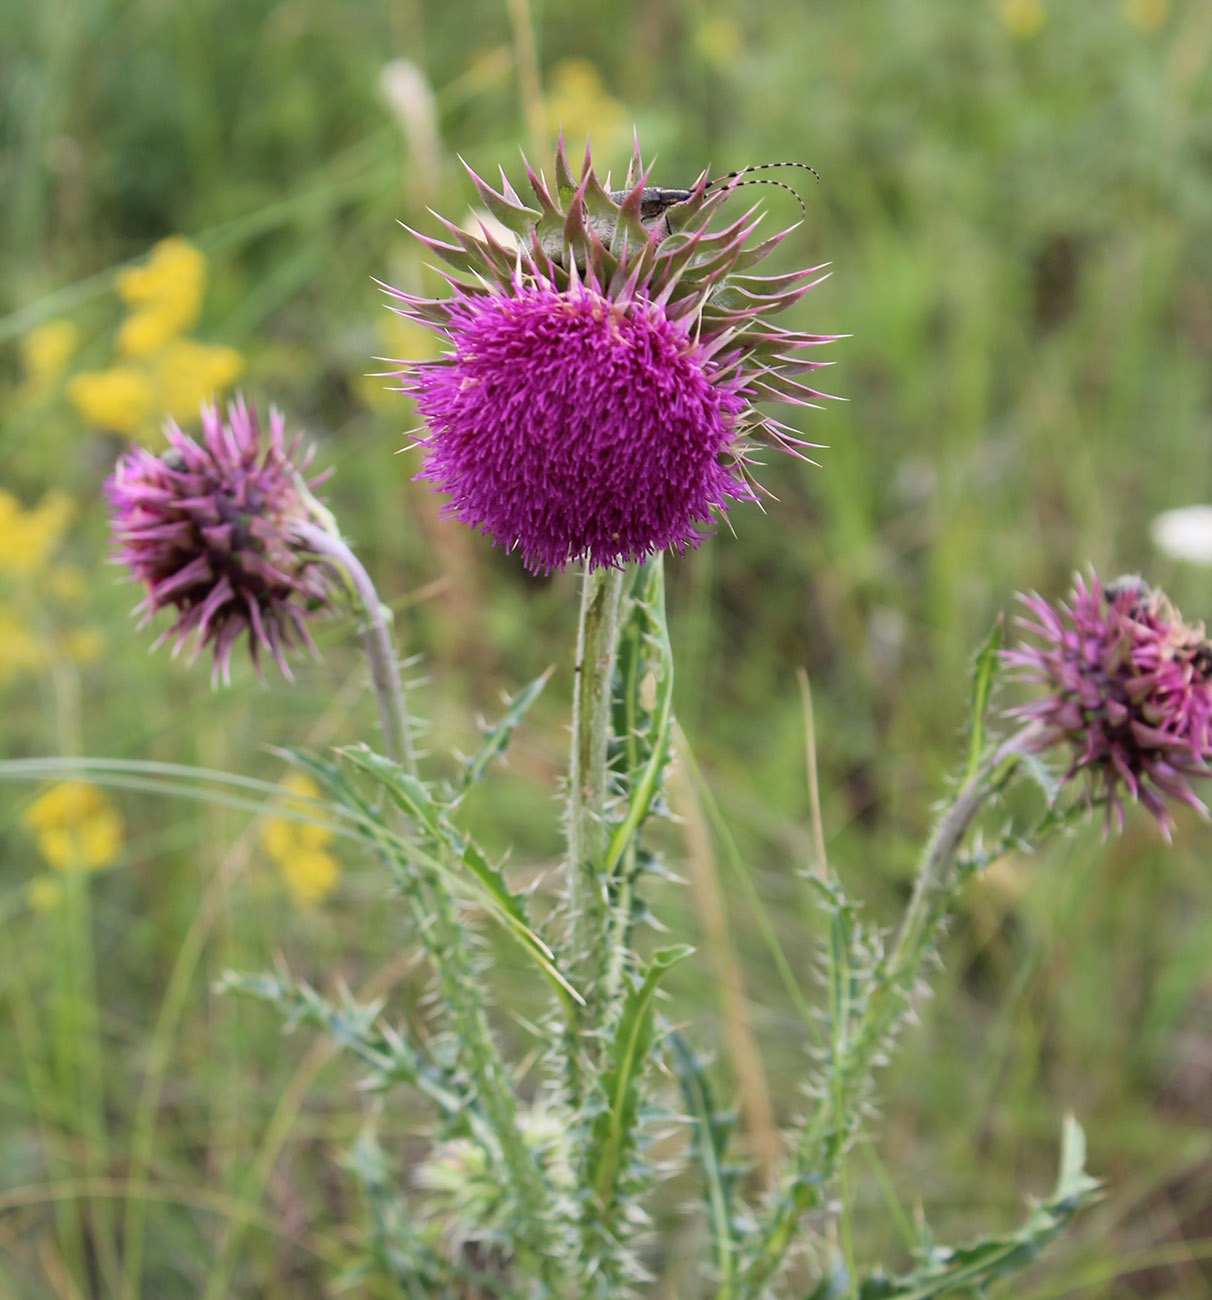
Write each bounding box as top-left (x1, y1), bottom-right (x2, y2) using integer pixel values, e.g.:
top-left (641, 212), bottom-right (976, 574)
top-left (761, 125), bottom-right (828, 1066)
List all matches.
top-left (64, 237), bottom-right (243, 438)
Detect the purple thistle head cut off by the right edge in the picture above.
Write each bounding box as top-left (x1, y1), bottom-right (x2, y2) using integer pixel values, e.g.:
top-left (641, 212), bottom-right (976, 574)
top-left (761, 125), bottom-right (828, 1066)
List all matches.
top-left (1003, 569), bottom-right (1212, 839)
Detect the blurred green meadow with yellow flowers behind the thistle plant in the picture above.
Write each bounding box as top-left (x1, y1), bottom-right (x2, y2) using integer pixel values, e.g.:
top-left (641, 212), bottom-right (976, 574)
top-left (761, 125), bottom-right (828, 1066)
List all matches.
top-left (0, 0), bottom-right (1212, 1300)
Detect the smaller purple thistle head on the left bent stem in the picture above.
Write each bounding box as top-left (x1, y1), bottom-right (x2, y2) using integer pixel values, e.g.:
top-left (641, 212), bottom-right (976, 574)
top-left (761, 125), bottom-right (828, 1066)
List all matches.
top-left (105, 400), bottom-right (332, 681)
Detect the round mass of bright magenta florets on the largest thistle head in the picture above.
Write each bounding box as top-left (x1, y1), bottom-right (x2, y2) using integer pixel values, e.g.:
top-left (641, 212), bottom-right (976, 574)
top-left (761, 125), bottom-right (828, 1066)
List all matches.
top-left (408, 282), bottom-right (752, 571)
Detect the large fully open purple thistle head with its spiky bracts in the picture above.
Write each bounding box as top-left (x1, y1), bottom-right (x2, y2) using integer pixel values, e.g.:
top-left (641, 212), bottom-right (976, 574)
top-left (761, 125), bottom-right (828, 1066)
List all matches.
top-left (384, 135), bottom-right (834, 572)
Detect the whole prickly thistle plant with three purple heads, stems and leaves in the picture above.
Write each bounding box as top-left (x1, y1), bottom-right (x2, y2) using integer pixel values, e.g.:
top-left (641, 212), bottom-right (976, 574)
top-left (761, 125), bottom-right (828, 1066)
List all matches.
top-left (82, 137), bottom-right (1212, 1300)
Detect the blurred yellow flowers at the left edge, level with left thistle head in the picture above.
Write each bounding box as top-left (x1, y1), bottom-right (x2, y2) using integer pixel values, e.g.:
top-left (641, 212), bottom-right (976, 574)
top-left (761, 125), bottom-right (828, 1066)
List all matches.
top-left (0, 489), bottom-right (104, 686)
